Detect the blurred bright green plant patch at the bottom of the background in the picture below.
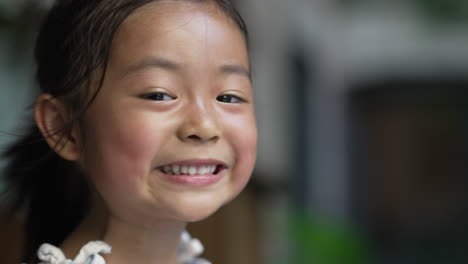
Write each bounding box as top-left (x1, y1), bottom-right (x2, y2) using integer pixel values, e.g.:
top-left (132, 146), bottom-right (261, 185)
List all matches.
top-left (289, 212), bottom-right (369, 264)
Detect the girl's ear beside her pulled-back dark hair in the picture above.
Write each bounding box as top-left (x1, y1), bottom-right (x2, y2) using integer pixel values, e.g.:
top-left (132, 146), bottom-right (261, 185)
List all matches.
top-left (34, 94), bottom-right (80, 161)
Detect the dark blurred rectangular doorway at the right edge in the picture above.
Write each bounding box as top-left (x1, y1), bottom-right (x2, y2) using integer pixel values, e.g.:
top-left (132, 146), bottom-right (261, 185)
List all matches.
top-left (349, 80), bottom-right (468, 264)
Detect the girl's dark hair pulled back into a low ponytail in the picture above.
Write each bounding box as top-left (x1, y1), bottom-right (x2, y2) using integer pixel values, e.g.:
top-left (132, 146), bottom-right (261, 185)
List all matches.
top-left (3, 0), bottom-right (247, 261)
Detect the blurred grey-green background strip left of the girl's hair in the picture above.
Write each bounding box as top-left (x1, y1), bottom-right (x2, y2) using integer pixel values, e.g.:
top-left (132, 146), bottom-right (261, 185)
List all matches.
top-left (0, 1), bottom-right (41, 190)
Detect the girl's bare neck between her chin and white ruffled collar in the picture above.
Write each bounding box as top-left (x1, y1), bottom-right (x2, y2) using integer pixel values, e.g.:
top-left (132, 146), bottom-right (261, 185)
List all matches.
top-left (61, 195), bottom-right (186, 264)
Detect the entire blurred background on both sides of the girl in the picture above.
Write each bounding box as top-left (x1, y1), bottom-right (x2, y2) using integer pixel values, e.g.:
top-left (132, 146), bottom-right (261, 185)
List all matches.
top-left (0, 0), bottom-right (468, 264)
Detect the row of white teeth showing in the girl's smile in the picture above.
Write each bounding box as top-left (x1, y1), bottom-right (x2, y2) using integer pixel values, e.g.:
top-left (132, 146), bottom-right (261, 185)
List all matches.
top-left (158, 164), bottom-right (225, 175)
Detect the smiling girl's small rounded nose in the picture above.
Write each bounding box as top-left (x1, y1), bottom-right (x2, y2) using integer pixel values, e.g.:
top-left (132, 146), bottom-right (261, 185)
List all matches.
top-left (177, 100), bottom-right (221, 143)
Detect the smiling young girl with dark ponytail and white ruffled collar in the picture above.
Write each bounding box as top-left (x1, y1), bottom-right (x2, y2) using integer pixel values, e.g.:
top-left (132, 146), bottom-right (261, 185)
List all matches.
top-left (0, 0), bottom-right (257, 264)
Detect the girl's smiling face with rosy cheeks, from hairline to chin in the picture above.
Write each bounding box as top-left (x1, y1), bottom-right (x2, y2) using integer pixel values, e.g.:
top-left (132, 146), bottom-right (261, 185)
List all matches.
top-left (80, 1), bottom-right (257, 226)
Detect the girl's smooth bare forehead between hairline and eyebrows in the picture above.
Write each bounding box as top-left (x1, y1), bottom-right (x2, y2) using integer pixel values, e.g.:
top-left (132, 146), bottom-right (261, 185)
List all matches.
top-left (111, 1), bottom-right (248, 69)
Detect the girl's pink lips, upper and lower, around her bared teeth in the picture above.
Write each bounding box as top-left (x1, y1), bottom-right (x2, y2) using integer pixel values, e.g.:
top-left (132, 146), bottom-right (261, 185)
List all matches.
top-left (156, 159), bottom-right (227, 187)
